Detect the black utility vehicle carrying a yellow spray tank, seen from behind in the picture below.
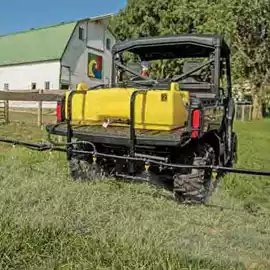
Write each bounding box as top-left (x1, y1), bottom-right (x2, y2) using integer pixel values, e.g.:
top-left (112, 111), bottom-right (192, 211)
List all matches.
top-left (46, 34), bottom-right (237, 203)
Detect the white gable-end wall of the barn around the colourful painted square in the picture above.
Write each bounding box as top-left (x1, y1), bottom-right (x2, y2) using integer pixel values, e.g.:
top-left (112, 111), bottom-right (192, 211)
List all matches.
top-left (61, 21), bottom-right (115, 89)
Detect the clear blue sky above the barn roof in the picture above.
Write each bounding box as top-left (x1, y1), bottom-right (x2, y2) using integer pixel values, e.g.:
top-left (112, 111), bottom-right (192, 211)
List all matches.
top-left (0, 0), bottom-right (126, 35)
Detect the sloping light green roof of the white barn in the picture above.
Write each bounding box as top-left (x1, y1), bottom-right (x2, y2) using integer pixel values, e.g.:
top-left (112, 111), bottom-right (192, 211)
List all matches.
top-left (0, 22), bottom-right (77, 66)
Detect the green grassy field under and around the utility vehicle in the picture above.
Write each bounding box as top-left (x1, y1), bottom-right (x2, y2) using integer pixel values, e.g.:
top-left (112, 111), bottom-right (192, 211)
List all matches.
top-left (0, 120), bottom-right (270, 270)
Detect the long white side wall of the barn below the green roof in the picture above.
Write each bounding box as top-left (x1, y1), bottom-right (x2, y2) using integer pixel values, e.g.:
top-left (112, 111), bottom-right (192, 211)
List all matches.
top-left (0, 61), bottom-right (60, 90)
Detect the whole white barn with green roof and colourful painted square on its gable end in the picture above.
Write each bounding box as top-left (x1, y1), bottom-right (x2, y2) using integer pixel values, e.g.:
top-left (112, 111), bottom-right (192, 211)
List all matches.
top-left (0, 15), bottom-right (116, 90)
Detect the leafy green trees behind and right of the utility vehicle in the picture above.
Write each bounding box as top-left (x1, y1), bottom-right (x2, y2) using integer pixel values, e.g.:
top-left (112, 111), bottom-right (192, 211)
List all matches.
top-left (111, 0), bottom-right (270, 119)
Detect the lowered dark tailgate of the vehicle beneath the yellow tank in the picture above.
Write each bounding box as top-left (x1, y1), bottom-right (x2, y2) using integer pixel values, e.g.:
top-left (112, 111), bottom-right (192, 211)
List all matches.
top-left (46, 123), bottom-right (188, 147)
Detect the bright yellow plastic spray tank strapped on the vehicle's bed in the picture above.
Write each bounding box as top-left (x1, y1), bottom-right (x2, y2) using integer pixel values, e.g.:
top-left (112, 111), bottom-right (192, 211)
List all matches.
top-left (66, 83), bottom-right (189, 130)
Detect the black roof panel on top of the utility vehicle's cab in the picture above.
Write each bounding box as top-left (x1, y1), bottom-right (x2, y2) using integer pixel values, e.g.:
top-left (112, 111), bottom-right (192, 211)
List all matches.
top-left (112, 34), bottom-right (230, 60)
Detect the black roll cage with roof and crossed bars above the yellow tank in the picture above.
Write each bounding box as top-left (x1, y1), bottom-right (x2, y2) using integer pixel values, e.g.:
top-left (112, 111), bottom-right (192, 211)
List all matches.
top-left (111, 34), bottom-right (231, 97)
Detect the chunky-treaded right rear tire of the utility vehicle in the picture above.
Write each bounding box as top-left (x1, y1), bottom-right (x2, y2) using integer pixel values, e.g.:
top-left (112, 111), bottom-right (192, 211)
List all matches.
top-left (173, 144), bottom-right (216, 204)
